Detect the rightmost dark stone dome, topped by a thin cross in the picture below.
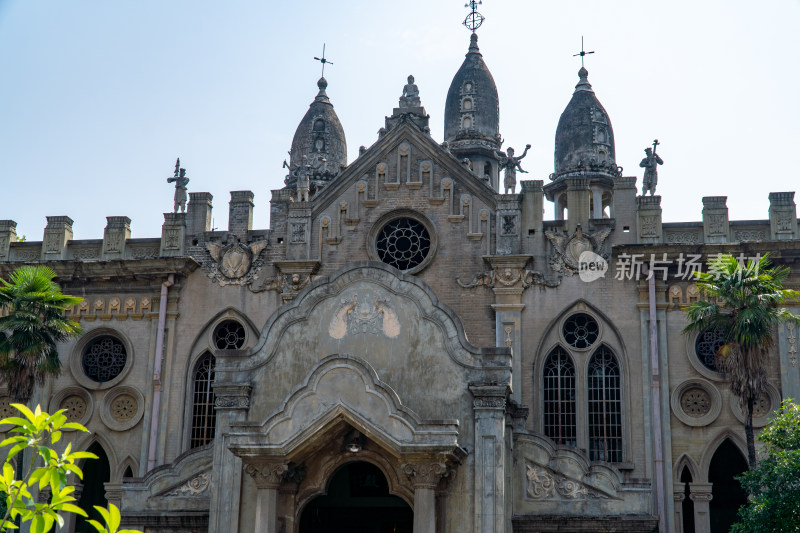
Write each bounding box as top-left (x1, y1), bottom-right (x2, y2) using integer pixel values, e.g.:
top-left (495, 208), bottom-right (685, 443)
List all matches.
top-left (551, 67), bottom-right (620, 179)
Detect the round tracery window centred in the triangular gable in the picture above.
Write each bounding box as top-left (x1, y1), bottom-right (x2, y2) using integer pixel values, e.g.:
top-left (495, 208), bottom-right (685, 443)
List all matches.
top-left (375, 217), bottom-right (431, 271)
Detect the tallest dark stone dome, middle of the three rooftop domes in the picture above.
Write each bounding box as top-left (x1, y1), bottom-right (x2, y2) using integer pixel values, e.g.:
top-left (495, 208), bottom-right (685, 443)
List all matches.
top-left (444, 33), bottom-right (500, 153)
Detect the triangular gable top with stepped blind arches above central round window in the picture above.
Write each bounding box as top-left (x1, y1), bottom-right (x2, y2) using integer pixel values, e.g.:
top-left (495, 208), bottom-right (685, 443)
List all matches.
top-left (311, 122), bottom-right (498, 217)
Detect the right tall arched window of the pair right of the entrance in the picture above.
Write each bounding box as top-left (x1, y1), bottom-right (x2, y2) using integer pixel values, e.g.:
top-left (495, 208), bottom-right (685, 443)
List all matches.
top-left (587, 346), bottom-right (622, 463)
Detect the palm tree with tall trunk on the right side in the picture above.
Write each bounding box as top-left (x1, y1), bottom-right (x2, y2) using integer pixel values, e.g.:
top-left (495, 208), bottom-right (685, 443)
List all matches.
top-left (683, 254), bottom-right (800, 468)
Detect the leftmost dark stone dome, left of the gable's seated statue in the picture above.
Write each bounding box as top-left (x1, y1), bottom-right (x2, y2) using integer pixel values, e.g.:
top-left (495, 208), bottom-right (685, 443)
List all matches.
top-left (285, 78), bottom-right (347, 190)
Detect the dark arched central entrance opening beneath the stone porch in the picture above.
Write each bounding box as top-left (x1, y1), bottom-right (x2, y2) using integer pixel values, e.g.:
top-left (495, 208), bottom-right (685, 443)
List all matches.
top-left (300, 462), bottom-right (414, 533)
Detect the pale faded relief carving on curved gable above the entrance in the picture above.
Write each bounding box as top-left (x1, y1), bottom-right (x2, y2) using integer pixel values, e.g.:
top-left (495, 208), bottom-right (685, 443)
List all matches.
top-left (328, 294), bottom-right (400, 339)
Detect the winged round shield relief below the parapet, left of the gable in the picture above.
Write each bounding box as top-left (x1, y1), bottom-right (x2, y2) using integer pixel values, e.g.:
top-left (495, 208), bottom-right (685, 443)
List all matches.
top-left (203, 241), bottom-right (267, 286)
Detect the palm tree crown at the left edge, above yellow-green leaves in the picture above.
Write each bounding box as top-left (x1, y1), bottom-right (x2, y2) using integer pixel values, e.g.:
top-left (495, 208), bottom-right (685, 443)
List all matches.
top-left (0, 266), bottom-right (83, 403)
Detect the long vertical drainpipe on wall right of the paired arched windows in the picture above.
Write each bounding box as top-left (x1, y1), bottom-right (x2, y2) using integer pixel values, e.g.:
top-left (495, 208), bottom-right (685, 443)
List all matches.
top-left (647, 269), bottom-right (667, 533)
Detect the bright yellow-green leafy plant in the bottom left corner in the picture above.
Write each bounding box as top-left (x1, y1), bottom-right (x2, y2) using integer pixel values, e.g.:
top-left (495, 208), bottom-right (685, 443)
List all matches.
top-left (0, 404), bottom-right (140, 533)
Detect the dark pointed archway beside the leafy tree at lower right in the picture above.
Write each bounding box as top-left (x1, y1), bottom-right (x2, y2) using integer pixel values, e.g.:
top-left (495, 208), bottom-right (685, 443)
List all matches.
top-left (708, 439), bottom-right (747, 533)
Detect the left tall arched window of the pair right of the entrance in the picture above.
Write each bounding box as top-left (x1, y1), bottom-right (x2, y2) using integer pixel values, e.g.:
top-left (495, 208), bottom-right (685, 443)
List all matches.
top-left (543, 347), bottom-right (577, 446)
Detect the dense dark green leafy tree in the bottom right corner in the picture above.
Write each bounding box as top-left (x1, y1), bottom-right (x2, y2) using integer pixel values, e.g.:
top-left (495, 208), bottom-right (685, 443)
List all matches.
top-left (731, 400), bottom-right (800, 533)
